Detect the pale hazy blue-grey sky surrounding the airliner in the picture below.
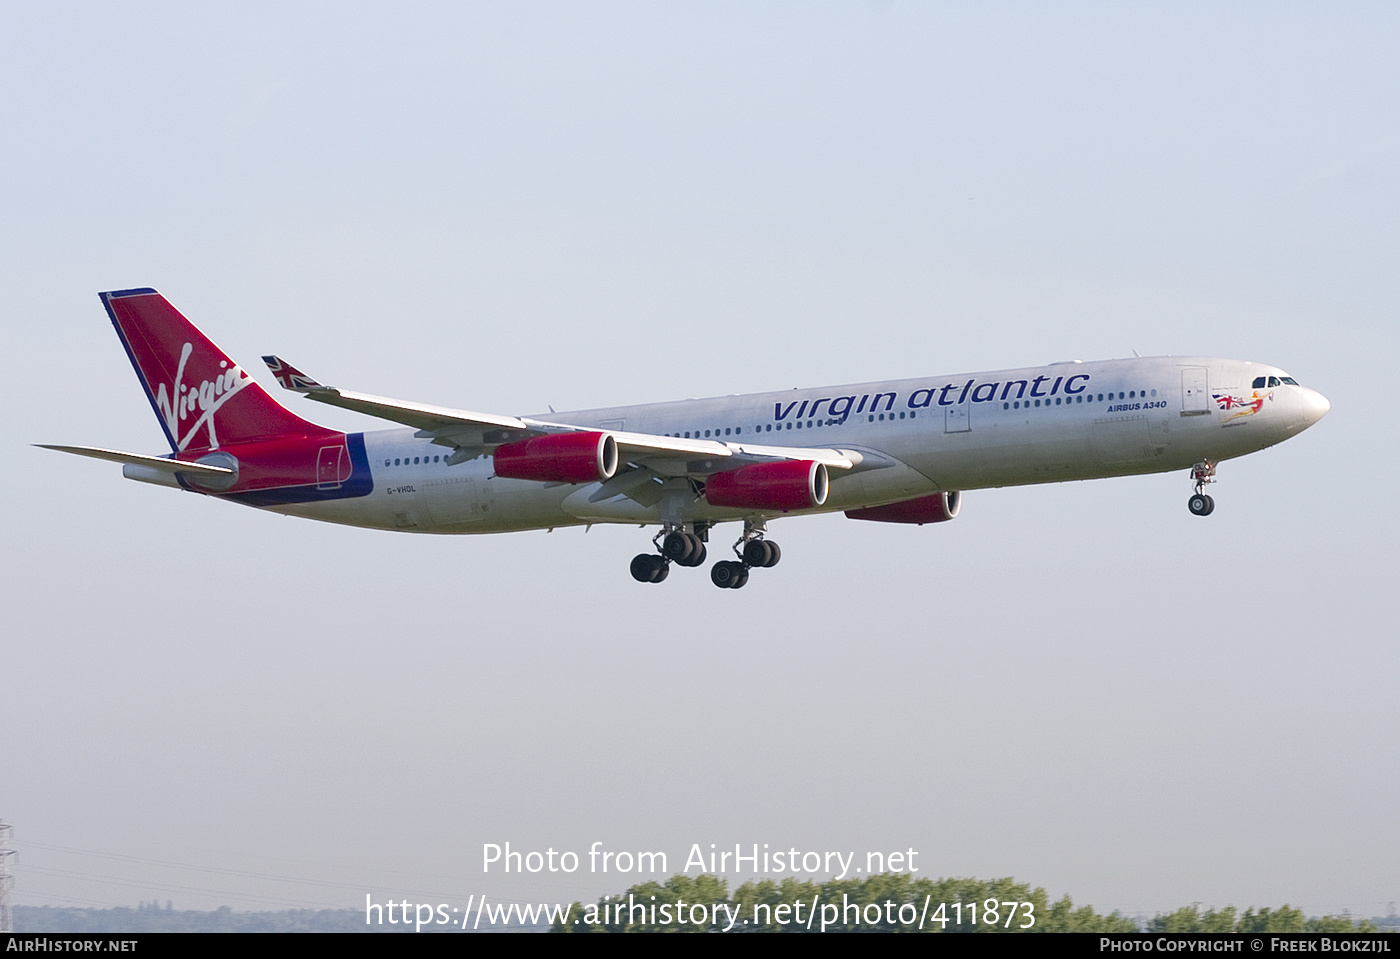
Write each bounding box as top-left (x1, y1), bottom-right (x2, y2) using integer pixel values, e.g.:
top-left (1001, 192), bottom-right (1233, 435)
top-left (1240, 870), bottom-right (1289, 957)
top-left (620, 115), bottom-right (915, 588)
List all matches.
top-left (0, 3), bottom-right (1400, 914)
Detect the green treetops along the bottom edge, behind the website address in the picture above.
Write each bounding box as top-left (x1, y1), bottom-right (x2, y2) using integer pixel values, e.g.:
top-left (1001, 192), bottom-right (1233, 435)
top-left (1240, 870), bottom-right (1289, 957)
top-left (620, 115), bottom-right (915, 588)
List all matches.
top-left (550, 874), bottom-right (1379, 932)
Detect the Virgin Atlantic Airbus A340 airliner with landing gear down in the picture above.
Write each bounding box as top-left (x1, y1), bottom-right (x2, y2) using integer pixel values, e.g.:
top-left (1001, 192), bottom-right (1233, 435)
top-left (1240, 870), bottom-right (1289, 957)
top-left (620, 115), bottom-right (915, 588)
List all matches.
top-left (46, 288), bottom-right (1330, 588)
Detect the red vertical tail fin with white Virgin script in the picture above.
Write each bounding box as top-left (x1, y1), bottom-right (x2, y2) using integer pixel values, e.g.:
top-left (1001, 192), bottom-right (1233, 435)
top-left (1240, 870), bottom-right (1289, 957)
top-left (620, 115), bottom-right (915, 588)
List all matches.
top-left (99, 290), bottom-right (329, 452)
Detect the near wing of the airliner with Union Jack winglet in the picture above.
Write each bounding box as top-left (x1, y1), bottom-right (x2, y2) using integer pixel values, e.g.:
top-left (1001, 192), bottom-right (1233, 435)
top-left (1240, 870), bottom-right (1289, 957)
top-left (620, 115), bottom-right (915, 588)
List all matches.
top-left (263, 356), bottom-right (864, 476)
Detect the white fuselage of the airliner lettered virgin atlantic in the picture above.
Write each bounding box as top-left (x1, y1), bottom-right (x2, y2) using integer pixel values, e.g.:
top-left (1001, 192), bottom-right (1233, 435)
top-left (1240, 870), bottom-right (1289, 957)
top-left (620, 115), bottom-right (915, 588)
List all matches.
top-left (273, 357), bottom-right (1327, 533)
